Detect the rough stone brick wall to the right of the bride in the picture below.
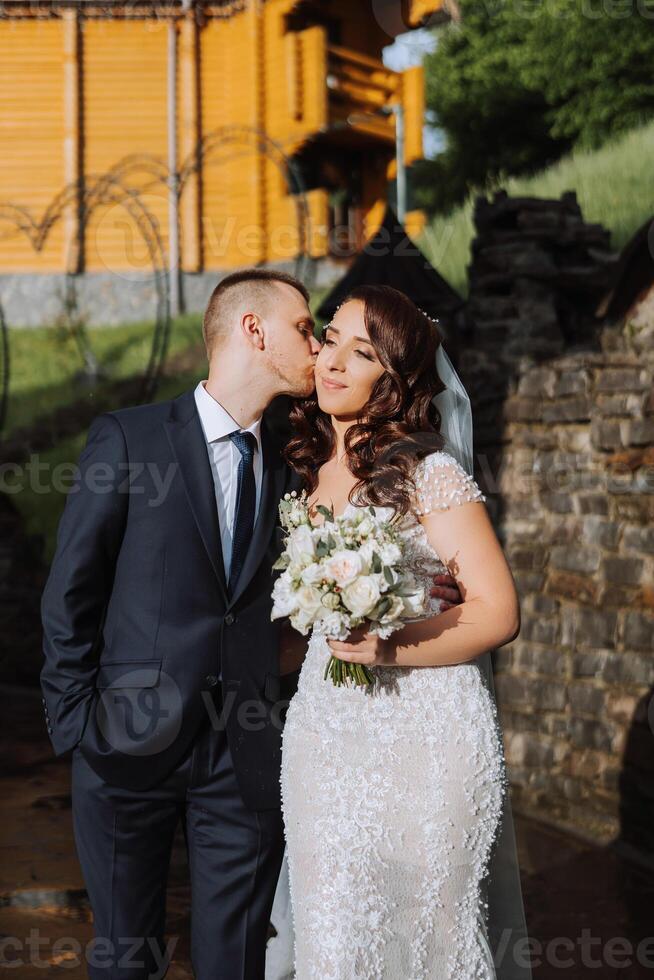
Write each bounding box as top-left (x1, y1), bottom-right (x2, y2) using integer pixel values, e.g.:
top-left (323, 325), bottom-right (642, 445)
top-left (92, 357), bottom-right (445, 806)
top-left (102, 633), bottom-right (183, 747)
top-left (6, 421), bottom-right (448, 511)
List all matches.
top-left (459, 189), bottom-right (654, 854)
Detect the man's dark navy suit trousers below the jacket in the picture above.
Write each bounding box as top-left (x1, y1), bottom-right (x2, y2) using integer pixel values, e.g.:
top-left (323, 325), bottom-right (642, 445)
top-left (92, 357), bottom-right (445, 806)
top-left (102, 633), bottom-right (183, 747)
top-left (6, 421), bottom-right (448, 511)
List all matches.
top-left (72, 688), bottom-right (284, 980)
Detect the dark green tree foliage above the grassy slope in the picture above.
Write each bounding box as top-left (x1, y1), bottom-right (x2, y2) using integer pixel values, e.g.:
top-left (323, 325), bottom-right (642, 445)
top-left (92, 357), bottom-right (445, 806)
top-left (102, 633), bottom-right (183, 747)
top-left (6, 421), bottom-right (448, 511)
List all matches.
top-left (414, 0), bottom-right (654, 211)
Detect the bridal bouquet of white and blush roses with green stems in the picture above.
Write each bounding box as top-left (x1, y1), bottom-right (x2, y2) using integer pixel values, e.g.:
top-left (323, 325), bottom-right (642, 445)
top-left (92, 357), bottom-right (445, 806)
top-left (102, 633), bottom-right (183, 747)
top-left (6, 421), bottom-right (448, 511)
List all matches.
top-left (271, 491), bottom-right (425, 686)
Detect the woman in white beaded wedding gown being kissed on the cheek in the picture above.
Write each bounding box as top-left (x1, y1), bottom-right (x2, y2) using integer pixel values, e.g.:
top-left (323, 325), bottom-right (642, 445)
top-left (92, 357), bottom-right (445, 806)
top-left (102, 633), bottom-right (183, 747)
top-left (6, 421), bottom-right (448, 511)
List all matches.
top-left (281, 285), bottom-right (530, 980)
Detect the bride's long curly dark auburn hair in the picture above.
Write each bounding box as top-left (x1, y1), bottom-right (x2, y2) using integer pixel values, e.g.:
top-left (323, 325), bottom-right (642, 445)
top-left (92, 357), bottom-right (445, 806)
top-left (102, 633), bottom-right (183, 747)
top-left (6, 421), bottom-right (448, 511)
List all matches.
top-left (283, 285), bottom-right (445, 517)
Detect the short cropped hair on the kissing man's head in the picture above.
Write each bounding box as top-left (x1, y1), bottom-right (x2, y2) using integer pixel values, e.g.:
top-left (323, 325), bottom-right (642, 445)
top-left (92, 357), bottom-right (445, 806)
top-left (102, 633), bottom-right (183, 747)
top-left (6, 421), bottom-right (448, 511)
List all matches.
top-left (202, 269), bottom-right (309, 355)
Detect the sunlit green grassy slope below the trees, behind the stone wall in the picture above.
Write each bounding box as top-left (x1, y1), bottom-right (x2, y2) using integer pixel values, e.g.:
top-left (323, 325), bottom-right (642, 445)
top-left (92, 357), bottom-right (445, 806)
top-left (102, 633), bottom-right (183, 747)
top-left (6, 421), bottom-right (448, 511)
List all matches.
top-left (418, 123), bottom-right (654, 296)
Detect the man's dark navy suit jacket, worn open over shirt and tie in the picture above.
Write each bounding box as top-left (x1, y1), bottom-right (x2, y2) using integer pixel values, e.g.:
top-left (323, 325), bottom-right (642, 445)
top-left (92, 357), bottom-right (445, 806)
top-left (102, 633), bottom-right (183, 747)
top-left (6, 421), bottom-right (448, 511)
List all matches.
top-left (41, 390), bottom-right (298, 809)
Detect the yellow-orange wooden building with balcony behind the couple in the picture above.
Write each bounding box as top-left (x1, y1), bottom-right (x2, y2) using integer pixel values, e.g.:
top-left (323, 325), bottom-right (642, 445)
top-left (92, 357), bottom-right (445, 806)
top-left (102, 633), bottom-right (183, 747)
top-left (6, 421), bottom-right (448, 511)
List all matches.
top-left (0, 0), bottom-right (447, 274)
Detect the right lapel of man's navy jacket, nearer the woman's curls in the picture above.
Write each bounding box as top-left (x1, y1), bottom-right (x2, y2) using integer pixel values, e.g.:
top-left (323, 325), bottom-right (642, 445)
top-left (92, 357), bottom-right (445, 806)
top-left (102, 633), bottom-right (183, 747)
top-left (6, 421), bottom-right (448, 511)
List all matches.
top-left (229, 415), bottom-right (288, 605)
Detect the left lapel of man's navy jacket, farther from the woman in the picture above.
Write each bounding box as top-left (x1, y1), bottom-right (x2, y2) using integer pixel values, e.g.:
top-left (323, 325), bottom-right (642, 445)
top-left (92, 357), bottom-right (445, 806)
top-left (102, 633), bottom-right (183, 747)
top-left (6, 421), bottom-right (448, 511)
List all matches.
top-left (164, 391), bottom-right (229, 605)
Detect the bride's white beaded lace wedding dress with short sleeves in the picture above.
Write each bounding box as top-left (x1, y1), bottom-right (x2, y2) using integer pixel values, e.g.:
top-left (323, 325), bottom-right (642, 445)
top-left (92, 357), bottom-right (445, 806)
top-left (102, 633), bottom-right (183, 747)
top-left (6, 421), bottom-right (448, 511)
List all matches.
top-left (281, 451), bottom-right (508, 980)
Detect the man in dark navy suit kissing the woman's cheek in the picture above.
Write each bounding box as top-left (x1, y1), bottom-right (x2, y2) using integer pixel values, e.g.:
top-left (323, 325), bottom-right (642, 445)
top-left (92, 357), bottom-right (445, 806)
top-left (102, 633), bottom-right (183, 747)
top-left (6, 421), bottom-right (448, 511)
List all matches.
top-left (41, 269), bottom-right (466, 980)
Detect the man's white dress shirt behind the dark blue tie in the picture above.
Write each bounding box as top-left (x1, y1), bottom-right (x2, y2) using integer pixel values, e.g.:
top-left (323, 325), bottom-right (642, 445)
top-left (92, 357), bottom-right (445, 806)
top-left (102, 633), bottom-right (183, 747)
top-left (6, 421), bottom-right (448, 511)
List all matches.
top-left (195, 380), bottom-right (263, 582)
